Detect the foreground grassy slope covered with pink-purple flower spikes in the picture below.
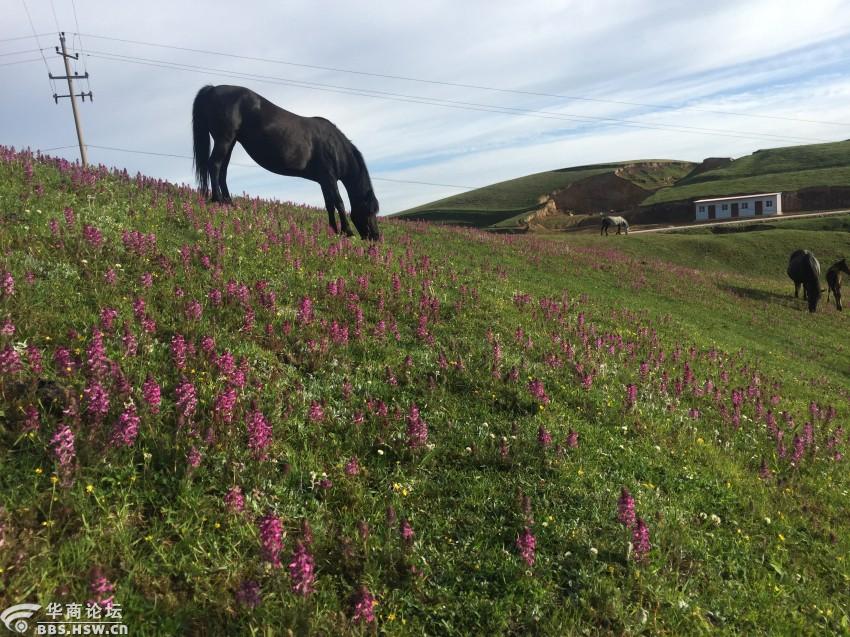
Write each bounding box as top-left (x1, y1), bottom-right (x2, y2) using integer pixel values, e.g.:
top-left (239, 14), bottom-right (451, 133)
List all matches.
top-left (0, 148), bottom-right (850, 636)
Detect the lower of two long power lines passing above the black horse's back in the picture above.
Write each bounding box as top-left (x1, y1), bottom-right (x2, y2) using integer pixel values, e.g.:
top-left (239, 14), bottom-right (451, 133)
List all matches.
top-left (83, 51), bottom-right (833, 143)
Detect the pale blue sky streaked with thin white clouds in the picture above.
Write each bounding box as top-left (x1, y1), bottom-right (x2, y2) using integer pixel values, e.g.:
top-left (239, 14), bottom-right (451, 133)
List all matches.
top-left (0, 0), bottom-right (850, 214)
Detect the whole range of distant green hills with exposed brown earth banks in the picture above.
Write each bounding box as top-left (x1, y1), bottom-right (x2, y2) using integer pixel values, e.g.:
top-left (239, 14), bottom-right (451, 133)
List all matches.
top-left (397, 141), bottom-right (850, 229)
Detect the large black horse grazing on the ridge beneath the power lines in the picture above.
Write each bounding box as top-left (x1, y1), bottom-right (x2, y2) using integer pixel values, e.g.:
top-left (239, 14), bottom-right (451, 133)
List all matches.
top-left (192, 85), bottom-right (380, 240)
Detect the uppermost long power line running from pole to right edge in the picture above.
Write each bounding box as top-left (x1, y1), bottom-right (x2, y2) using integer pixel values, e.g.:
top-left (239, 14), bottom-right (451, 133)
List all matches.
top-left (78, 34), bottom-right (850, 126)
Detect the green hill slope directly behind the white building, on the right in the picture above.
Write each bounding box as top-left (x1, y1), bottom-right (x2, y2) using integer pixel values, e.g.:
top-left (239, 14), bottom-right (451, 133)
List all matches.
top-left (644, 141), bottom-right (850, 205)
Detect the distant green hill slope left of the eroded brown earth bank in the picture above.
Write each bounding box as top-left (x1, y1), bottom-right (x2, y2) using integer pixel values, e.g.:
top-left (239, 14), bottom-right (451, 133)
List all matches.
top-left (396, 160), bottom-right (691, 227)
